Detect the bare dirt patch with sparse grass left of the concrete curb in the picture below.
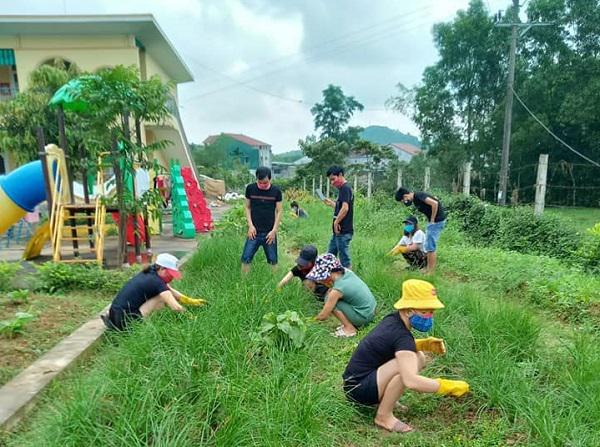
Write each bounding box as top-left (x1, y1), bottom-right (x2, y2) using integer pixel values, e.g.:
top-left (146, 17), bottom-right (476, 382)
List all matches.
top-left (0, 294), bottom-right (111, 385)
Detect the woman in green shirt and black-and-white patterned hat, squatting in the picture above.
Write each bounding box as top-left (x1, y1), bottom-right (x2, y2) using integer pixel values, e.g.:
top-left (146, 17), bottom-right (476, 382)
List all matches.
top-left (306, 253), bottom-right (377, 337)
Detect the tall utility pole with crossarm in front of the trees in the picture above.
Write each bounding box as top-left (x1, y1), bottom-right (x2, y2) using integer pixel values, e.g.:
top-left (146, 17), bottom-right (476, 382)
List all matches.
top-left (496, 0), bottom-right (553, 205)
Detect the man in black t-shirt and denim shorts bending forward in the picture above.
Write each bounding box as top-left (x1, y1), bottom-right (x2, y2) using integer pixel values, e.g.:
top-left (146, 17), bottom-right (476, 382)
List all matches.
top-left (396, 188), bottom-right (446, 274)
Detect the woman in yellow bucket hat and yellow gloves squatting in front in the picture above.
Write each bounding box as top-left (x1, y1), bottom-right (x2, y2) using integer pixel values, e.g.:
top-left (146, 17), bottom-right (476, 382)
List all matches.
top-left (343, 279), bottom-right (469, 433)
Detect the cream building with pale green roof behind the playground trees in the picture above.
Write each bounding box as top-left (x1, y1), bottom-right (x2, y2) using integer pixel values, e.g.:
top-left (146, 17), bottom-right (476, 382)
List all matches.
top-left (0, 14), bottom-right (195, 178)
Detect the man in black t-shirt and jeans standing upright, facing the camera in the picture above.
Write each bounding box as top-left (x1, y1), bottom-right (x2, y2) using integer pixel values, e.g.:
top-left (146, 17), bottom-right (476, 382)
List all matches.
top-left (242, 166), bottom-right (283, 273)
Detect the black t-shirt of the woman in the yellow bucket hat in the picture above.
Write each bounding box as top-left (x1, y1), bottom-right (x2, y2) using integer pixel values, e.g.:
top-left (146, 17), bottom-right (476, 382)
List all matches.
top-left (343, 311), bottom-right (417, 381)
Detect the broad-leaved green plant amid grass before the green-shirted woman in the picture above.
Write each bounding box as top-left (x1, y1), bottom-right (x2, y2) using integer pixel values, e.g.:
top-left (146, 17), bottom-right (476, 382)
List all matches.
top-left (256, 310), bottom-right (306, 349)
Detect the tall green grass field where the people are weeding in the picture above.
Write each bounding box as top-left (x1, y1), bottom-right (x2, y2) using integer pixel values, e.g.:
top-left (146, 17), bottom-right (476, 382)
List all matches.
top-left (0, 202), bottom-right (600, 447)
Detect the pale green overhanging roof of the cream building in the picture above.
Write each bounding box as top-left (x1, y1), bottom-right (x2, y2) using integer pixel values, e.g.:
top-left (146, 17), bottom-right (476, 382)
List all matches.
top-left (0, 14), bottom-right (194, 83)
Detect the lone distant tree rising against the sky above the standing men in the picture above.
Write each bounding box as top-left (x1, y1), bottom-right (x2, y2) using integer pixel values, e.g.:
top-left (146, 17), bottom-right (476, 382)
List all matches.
top-left (310, 84), bottom-right (364, 141)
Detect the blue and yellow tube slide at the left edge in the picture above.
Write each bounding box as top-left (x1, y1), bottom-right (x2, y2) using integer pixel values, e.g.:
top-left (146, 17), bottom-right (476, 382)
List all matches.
top-left (0, 160), bottom-right (46, 238)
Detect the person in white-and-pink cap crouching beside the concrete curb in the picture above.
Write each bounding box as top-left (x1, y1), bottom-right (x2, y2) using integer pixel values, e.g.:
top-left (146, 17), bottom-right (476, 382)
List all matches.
top-left (101, 253), bottom-right (185, 330)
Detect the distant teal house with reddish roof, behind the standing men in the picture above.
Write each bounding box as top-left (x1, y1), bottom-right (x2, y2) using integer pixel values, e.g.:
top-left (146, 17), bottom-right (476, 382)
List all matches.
top-left (203, 133), bottom-right (272, 170)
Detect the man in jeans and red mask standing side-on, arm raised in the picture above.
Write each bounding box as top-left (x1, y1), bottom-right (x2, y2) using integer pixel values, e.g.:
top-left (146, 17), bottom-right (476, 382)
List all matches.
top-left (324, 166), bottom-right (354, 269)
